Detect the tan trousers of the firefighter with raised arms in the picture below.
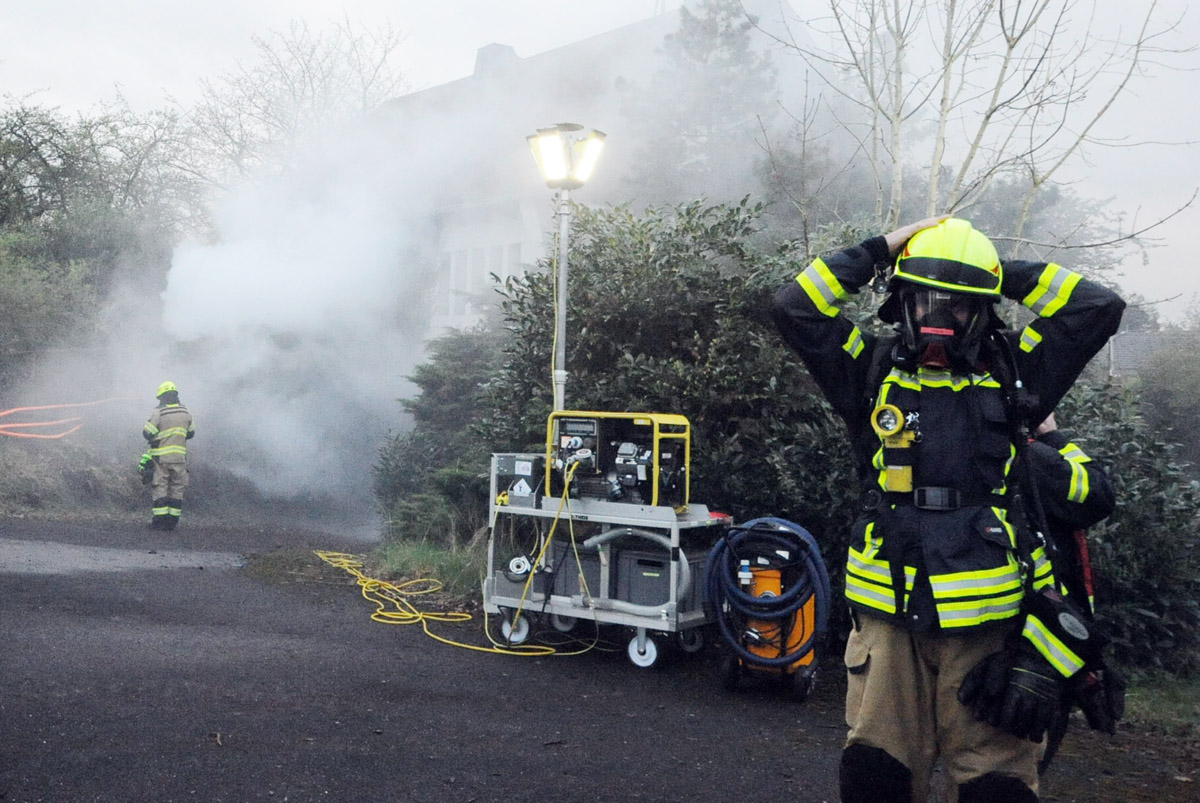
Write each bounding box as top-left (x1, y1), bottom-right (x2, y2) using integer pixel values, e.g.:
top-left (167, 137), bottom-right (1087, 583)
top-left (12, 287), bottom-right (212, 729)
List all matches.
top-left (846, 617), bottom-right (1042, 802)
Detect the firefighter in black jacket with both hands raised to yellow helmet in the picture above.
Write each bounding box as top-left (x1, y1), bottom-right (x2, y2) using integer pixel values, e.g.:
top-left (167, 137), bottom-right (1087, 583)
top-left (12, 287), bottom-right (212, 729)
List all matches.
top-left (774, 217), bottom-right (1124, 803)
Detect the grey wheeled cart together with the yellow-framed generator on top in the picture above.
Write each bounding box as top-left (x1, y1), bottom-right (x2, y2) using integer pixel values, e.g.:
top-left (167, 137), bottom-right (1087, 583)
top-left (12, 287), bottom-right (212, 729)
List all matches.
top-left (484, 411), bottom-right (730, 667)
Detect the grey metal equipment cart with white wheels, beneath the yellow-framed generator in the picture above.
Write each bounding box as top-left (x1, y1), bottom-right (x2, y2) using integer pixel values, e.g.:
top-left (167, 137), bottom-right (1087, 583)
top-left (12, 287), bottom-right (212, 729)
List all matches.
top-left (484, 454), bottom-right (730, 667)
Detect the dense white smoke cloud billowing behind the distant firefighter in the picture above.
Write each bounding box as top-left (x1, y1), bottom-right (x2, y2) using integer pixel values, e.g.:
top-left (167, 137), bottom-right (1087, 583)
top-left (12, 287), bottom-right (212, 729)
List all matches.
top-left (7, 118), bottom-right (439, 526)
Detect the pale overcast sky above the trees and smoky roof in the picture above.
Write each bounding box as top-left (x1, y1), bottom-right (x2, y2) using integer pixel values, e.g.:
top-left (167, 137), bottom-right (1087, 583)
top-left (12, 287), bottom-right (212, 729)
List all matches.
top-left (0, 0), bottom-right (1200, 317)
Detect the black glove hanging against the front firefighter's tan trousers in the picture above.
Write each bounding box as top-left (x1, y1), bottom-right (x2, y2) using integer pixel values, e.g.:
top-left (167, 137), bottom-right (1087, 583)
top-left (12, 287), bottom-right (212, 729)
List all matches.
top-left (959, 648), bottom-right (1063, 742)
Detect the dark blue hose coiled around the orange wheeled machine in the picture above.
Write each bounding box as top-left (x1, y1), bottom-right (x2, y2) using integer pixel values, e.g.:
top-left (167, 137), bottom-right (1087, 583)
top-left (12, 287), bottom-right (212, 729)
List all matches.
top-left (704, 517), bottom-right (830, 666)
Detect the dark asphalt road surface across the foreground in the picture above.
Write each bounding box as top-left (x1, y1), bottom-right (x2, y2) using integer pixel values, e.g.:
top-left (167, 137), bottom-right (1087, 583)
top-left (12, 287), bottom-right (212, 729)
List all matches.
top-left (0, 520), bottom-right (842, 803)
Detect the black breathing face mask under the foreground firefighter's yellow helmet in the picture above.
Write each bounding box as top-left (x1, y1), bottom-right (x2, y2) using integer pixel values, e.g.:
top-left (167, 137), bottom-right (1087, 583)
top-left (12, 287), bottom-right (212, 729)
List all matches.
top-left (899, 288), bottom-right (988, 373)
